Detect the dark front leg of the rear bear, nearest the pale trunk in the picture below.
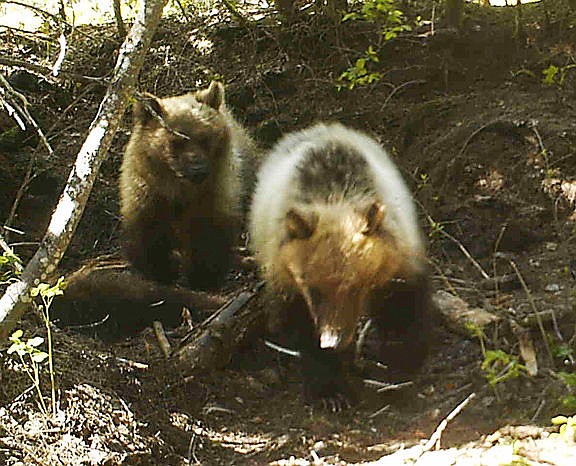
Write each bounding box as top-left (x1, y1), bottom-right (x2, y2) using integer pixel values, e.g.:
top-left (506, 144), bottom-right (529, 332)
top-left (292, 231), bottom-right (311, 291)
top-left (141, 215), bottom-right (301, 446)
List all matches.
top-left (124, 206), bottom-right (178, 284)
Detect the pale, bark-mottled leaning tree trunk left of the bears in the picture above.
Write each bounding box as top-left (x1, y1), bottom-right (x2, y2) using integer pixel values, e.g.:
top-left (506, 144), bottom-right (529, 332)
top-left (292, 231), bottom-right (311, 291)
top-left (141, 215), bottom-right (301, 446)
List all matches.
top-left (0, 0), bottom-right (166, 341)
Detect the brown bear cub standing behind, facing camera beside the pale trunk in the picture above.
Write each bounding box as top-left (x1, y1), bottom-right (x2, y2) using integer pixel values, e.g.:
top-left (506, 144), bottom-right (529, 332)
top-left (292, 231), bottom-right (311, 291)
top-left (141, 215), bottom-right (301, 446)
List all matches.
top-left (120, 82), bottom-right (253, 289)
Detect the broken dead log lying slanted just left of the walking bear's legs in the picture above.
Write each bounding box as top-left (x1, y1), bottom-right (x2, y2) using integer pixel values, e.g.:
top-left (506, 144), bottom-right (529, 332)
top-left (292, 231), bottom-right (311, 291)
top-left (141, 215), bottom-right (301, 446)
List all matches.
top-left (172, 282), bottom-right (264, 370)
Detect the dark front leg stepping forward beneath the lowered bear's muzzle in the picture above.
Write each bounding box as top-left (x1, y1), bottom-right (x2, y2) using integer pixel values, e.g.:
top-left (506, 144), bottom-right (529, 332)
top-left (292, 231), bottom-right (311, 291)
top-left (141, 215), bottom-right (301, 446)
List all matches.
top-left (274, 296), bottom-right (355, 411)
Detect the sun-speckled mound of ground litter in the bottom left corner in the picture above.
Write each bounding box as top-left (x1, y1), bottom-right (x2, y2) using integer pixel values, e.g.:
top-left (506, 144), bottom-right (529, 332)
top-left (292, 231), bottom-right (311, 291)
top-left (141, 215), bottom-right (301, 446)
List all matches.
top-left (0, 384), bottom-right (158, 466)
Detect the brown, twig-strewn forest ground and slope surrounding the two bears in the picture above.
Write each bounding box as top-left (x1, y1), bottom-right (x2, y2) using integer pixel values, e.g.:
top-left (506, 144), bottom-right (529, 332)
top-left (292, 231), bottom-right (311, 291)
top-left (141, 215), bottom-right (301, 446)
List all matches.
top-left (0, 3), bottom-right (576, 466)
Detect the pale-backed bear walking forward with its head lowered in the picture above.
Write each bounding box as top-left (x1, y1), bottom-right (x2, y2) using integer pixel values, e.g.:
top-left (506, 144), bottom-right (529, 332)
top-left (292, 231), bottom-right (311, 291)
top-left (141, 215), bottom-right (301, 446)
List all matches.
top-left (250, 124), bottom-right (430, 410)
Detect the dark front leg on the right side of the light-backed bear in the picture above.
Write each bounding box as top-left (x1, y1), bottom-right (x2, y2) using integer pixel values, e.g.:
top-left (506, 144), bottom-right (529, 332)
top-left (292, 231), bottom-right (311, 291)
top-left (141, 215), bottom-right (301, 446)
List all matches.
top-left (365, 275), bottom-right (432, 374)
